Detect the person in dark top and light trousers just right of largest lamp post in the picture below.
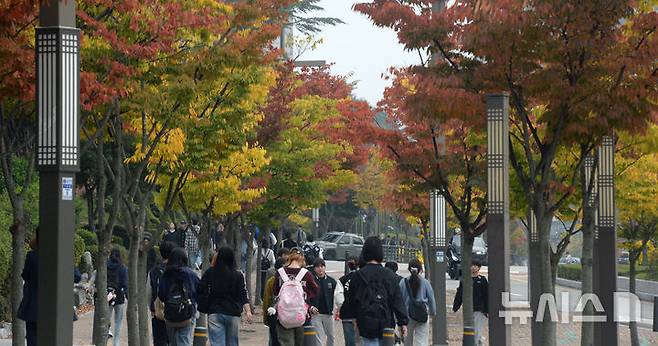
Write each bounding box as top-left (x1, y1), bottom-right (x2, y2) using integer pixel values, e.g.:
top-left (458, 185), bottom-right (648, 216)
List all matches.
top-left (107, 248), bottom-right (128, 346)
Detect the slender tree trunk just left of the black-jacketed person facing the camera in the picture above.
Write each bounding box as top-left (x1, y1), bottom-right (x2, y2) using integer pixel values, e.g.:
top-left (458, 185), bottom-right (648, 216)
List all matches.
top-left (460, 232), bottom-right (475, 346)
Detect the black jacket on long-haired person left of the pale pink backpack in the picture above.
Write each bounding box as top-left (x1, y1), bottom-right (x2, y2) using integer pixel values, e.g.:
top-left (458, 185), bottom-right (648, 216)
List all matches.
top-left (197, 267), bottom-right (249, 316)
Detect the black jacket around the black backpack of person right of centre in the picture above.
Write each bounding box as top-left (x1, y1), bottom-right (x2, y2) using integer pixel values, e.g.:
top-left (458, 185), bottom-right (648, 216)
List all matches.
top-left (343, 264), bottom-right (409, 327)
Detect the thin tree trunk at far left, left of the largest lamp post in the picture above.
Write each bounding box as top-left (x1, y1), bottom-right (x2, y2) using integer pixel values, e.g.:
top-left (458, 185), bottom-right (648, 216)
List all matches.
top-left (11, 218), bottom-right (26, 345)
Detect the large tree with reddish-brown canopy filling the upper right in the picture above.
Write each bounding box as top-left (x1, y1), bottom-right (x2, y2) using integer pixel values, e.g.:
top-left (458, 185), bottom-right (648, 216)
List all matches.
top-left (357, 0), bottom-right (658, 345)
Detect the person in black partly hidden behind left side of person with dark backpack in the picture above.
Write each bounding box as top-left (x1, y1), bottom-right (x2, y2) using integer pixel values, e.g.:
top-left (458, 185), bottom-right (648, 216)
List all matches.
top-left (146, 241), bottom-right (176, 346)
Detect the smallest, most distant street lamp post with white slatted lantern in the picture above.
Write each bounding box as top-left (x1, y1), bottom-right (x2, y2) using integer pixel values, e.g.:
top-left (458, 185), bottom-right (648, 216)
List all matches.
top-left (425, 190), bottom-right (448, 345)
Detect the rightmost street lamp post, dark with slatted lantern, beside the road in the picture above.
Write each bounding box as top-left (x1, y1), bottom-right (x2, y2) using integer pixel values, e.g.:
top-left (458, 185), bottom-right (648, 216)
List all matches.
top-left (593, 136), bottom-right (619, 346)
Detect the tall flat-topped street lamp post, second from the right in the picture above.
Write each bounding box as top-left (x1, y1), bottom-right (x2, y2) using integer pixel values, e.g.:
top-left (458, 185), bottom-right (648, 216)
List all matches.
top-left (487, 94), bottom-right (510, 345)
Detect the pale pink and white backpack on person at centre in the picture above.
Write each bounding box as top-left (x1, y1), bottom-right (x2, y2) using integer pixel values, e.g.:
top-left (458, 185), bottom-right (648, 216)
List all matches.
top-left (276, 268), bottom-right (308, 329)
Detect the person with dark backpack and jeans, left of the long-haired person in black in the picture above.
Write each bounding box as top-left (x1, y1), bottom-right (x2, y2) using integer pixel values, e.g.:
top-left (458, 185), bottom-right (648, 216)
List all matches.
top-left (158, 247), bottom-right (199, 346)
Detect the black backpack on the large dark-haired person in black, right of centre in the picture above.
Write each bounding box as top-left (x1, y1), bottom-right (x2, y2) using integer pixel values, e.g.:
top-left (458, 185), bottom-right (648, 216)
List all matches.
top-left (356, 270), bottom-right (390, 339)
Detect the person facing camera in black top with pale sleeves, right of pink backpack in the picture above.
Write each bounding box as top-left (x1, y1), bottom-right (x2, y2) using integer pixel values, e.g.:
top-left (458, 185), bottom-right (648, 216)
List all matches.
top-left (311, 258), bottom-right (345, 346)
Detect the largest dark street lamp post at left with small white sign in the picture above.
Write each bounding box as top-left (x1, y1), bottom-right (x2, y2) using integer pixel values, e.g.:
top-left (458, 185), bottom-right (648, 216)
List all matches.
top-left (35, 0), bottom-right (80, 346)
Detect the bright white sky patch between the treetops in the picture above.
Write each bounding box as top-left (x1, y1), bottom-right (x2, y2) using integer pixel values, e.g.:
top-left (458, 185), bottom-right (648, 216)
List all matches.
top-left (298, 0), bottom-right (419, 106)
